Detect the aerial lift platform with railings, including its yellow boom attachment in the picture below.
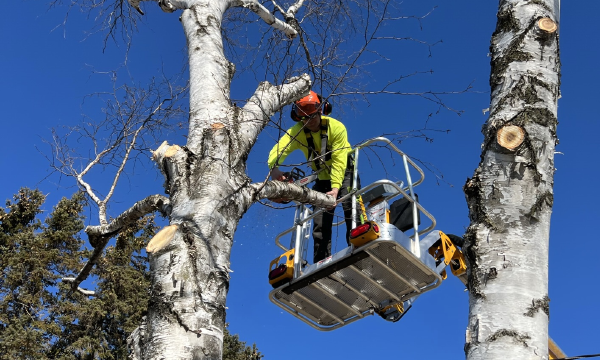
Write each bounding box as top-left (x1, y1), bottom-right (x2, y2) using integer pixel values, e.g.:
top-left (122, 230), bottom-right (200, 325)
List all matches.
top-left (269, 137), bottom-right (466, 331)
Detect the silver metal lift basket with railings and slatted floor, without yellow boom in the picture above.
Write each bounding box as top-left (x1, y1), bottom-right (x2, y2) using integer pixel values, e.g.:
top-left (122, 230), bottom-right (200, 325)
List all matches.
top-left (269, 138), bottom-right (445, 331)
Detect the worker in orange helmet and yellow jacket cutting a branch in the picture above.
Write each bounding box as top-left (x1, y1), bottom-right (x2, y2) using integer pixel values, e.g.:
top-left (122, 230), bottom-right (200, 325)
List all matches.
top-left (268, 91), bottom-right (360, 263)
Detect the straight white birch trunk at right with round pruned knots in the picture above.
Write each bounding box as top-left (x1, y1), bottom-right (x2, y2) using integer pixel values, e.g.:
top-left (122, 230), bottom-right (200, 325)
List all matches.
top-left (464, 0), bottom-right (560, 360)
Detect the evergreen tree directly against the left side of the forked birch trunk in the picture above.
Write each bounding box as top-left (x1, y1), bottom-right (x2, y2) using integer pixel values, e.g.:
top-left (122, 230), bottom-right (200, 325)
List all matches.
top-left (50, 217), bottom-right (155, 360)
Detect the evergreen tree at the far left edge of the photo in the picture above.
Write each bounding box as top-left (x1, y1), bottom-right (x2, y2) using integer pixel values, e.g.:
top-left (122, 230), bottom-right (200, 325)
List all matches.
top-left (0, 189), bottom-right (84, 359)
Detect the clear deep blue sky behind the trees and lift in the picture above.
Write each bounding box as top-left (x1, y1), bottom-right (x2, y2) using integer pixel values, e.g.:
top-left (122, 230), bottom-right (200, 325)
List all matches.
top-left (0, 0), bottom-right (600, 360)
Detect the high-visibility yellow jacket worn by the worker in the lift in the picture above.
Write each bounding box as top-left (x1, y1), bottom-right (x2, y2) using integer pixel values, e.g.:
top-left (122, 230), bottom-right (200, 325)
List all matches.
top-left (268, 115), bottom-right (352, 189)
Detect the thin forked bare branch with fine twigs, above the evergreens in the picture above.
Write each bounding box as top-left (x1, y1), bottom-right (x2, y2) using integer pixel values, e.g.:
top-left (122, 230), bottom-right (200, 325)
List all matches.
top-left (49, 71), bottom-right (187, 225)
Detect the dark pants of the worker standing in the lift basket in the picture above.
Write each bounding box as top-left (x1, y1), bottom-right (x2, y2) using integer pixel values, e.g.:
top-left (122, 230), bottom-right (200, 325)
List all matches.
top-left (313, 168), bottom-right (360, 263)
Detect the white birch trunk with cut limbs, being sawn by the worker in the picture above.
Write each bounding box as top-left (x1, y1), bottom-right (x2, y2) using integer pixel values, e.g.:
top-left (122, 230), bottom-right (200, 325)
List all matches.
top-left (125, 0), bottom-right (334, 359)
